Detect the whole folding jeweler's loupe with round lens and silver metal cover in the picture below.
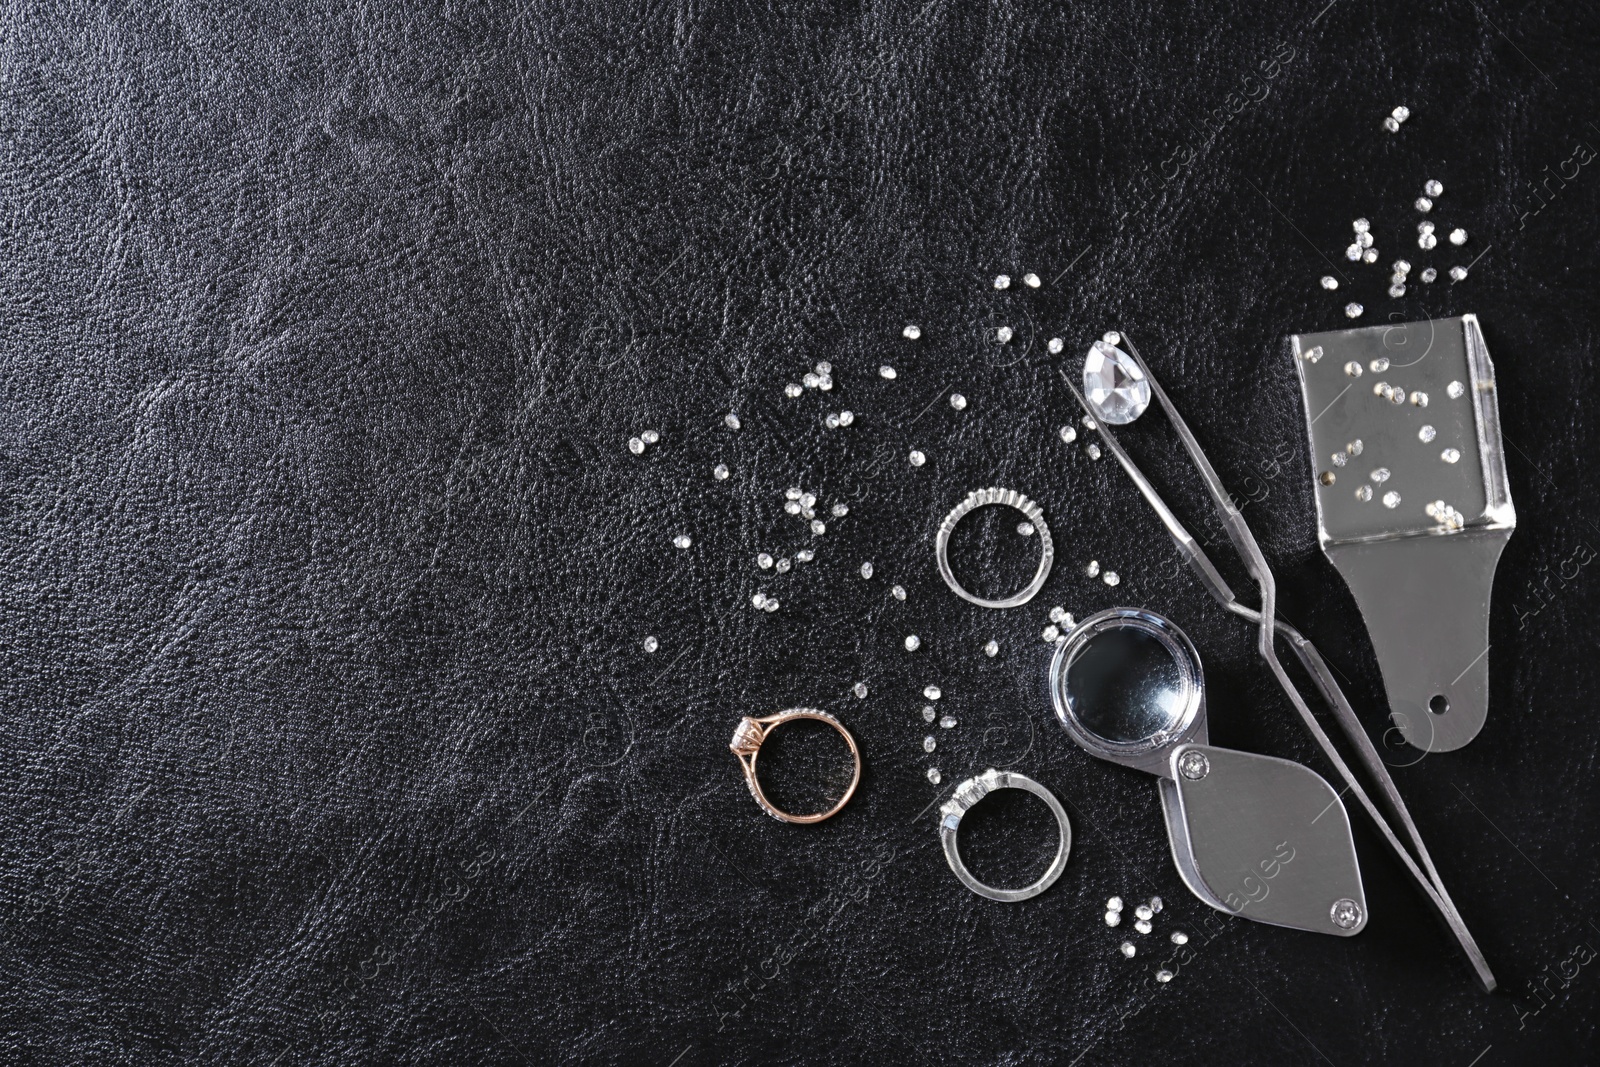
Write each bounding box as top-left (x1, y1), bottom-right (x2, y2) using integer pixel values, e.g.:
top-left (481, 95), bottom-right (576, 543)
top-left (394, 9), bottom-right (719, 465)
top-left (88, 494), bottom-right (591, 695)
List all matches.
top-left (1050, 608), bottom-right (1366, 937)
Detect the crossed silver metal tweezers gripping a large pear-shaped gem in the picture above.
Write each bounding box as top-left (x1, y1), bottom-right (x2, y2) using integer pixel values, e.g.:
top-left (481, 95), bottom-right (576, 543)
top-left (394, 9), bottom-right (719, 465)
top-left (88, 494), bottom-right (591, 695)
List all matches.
top-left (1061, 334), bottom-right (1496, 992)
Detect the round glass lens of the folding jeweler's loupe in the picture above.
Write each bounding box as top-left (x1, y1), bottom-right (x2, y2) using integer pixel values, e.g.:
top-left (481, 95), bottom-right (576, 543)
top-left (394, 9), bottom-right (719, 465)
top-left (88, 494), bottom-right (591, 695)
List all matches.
top-left (1066, 625), bottom-right (1189, 744)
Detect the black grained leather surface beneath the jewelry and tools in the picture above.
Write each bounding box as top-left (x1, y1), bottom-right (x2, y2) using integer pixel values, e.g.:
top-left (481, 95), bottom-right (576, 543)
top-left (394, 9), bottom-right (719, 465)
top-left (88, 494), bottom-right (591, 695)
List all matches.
top-left (0, 0), bottom-right (1600, 1067)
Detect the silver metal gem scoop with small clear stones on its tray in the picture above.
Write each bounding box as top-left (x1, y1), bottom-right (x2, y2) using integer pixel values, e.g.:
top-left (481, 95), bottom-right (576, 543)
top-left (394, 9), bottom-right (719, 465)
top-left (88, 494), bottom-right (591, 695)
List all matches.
top-left (1291, 315), bottom-right (1517, 752)
